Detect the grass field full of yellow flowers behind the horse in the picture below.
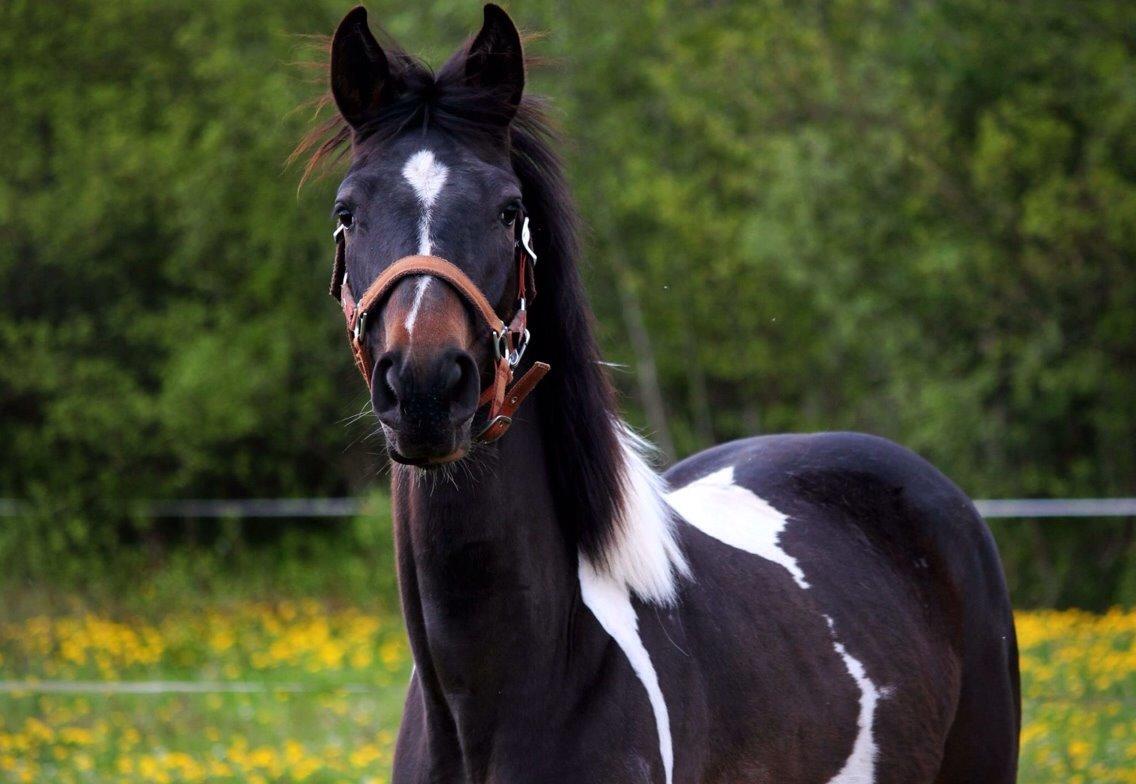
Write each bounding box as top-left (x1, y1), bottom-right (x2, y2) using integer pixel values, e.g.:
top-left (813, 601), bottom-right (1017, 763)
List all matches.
top-left (0, 601), bottom-right (1136, 784)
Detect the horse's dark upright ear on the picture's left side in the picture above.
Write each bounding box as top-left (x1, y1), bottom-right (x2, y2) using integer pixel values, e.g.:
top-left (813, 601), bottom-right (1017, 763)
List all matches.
top-left (332, 6), bottom-right (394, 131)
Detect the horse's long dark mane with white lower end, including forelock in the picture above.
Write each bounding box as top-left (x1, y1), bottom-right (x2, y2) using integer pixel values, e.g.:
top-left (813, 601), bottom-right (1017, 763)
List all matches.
top-left (290, 33), bottom-right (686, 603)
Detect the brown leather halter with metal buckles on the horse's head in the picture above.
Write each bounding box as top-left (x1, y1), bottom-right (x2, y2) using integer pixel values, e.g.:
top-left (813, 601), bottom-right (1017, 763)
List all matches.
top-left (331, 214), bottom-right (549, 443)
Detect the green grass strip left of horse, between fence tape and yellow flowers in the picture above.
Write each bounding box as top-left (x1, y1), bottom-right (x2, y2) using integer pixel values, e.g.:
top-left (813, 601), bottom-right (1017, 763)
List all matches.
top-left (0, 491), bottom-right (399, 619)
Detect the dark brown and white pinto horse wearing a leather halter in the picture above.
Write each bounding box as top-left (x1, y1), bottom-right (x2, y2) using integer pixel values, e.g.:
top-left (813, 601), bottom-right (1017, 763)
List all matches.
top-left (298, 5), bottom-right (1020, 784)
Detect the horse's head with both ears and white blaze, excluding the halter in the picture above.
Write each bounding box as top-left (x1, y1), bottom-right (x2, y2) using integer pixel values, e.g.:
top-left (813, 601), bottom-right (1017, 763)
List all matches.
top-left (332, 6), bottom-right (524, 467)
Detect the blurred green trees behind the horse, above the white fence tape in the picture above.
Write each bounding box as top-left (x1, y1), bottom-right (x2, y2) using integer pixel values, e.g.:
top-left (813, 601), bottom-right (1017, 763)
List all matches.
top-left (0, 0), bottom-right (1136, 603)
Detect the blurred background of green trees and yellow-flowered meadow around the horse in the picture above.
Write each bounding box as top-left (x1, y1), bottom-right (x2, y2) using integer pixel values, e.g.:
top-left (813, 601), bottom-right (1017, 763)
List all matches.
top-left (0, 0), bottom-right (1136, 782)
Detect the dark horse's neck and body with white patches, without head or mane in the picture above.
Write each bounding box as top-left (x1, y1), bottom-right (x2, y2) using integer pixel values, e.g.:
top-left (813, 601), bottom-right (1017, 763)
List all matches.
top-left (394, 425), bottom-right (1018, 784)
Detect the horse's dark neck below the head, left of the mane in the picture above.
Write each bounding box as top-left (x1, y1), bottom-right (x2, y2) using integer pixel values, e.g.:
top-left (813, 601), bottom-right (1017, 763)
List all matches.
top-left (393, 411), bottom-right (578, 712)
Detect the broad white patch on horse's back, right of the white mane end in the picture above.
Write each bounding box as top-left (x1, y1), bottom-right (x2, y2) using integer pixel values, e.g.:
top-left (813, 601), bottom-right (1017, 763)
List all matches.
top-left (667, 466), bottom-right (809, 589)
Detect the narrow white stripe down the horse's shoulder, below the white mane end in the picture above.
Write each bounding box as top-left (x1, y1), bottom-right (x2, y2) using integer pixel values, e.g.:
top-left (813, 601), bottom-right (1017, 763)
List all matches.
top-left (579, 553), bottom-right (675, 784)
